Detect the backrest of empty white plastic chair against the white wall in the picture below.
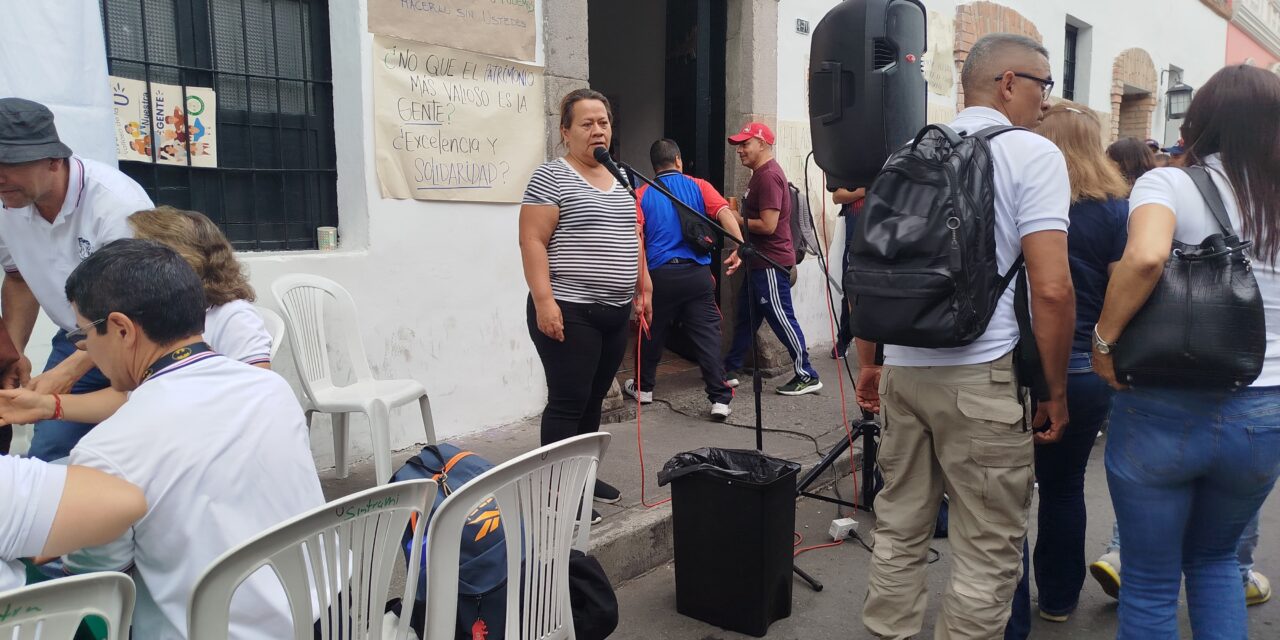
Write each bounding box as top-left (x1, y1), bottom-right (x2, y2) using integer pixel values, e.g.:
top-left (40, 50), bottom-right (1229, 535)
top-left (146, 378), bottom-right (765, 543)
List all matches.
top-left (271, 274), bottom-right (374, 399)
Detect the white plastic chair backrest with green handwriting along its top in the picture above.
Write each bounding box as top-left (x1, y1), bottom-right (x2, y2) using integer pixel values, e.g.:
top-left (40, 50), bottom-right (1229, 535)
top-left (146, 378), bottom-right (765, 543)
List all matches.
top-left (187, 479), bottom-right (436, 640)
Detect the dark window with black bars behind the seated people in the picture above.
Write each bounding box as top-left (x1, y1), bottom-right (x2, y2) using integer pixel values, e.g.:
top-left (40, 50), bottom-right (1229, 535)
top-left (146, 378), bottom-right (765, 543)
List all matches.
top-left (100, 0), bottom-right (338, 251)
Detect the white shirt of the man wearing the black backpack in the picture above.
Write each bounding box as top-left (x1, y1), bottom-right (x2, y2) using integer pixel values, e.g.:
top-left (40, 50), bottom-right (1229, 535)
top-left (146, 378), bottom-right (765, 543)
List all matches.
top-left (884, 106), bottom-right (1071, 366)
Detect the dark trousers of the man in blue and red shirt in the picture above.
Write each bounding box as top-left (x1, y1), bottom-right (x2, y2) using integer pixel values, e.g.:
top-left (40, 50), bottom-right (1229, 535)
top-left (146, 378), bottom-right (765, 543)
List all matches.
top-left (640, 264), bottom-right (733, 404)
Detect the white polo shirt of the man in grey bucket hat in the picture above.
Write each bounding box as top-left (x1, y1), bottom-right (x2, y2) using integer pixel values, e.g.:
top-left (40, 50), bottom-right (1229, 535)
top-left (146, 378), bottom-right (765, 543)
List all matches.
top-left (0, 156), bottom-right (155, 332)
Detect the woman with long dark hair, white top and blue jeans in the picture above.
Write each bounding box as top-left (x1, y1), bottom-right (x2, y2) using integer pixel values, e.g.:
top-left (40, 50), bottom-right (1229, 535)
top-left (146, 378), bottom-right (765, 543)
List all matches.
top-left (1093, 65), bottom-right (1280, 639)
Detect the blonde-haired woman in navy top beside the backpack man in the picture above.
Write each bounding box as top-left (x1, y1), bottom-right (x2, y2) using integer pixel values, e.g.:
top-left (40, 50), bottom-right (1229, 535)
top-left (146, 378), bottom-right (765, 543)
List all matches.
top-left (1011, 102), bottom-right (1131, 628)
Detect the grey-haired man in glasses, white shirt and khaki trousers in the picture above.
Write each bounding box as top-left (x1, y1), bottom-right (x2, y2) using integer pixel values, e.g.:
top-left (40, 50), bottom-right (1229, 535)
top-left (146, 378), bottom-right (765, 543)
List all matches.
top-left (856, 33), bottom-right (1075, 640)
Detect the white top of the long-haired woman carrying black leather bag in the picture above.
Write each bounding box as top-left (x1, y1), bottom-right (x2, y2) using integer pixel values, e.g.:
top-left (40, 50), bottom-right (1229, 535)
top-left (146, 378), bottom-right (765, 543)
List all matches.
top-left (1129, 154), bottom-right (1280, 387)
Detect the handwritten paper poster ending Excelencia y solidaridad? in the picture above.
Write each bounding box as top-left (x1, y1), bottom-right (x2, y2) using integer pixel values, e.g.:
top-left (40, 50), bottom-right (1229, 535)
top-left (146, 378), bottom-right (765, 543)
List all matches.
top-left (372, 36), bottom-right (547, 202)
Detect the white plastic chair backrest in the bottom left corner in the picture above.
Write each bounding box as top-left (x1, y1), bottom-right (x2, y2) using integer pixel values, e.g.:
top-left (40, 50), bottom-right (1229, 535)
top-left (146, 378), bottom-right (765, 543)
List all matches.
top-left (0, 571), bottom-right (134, 640)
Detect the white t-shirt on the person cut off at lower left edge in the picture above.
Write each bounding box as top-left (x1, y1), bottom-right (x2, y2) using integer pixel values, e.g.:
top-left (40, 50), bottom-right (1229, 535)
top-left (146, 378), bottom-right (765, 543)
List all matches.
top-left (0, 456), bottom-right (67, 591)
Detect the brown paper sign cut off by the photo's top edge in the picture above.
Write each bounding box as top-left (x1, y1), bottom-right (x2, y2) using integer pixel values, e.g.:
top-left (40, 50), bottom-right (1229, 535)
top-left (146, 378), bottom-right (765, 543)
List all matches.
top-left (369, 0), bottom-right (538, 60)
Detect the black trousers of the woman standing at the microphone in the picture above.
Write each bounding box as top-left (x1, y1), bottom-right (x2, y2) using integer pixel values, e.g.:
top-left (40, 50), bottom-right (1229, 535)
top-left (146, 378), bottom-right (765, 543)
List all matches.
top-left (526, 297), bottom-right (631, 444)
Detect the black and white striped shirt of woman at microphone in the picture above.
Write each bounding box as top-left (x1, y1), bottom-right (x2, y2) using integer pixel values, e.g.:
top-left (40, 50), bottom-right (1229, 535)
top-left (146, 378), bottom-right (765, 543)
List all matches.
top-left (522, 157), bottom-right (640, 307)
